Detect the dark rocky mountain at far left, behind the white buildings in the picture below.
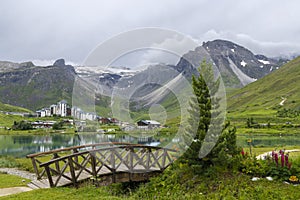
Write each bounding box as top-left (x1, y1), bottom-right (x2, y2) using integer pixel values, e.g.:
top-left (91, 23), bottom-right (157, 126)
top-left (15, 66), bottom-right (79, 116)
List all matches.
top-left (0, 59), bottom-right (76, 110)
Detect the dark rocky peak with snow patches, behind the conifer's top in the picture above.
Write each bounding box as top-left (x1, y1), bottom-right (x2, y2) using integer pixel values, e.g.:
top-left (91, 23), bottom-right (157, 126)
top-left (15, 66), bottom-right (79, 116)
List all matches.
top-left (176, 40), bottom-right (288, 88)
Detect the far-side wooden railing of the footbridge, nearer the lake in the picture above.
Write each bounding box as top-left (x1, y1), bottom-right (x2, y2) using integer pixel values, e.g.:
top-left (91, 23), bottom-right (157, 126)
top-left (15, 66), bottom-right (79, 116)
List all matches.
top-left (26, 142), bottom-right (132, 180)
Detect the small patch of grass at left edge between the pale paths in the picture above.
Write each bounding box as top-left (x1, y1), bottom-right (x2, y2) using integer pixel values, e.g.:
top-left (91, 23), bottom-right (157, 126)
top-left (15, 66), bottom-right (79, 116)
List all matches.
top-left (0, 173), bottom-right (30, 188)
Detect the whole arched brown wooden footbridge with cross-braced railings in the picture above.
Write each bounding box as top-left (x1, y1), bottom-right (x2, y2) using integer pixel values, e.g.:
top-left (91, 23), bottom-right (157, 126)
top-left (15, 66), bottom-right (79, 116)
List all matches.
top-left (27, 143), bottom-right (175, 188)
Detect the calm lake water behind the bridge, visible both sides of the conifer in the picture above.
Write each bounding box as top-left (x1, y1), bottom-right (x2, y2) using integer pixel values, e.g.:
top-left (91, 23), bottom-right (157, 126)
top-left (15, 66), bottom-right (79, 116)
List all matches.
top-left (0, 133), bottom-right (300, 157)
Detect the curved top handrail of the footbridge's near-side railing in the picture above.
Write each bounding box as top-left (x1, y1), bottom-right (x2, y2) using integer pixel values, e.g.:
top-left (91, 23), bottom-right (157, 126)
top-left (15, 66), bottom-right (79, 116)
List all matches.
top-left (39, 144), bottom-right (177, 167)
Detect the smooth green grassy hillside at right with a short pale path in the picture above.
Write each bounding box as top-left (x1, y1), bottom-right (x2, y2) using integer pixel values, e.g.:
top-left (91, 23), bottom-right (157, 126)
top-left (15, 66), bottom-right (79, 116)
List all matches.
top-left (228, 57), bottom-right (300, 114)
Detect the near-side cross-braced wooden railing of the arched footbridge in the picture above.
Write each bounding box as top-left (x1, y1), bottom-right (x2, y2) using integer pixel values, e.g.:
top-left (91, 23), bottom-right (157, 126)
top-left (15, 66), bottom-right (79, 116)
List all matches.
top-left (40, 145), bottom-right (176, 187)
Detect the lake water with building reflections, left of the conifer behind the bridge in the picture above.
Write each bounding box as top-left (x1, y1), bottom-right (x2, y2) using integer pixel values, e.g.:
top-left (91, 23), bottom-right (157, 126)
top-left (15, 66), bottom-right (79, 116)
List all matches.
top-left (0, 133), bottom-right (160, 157)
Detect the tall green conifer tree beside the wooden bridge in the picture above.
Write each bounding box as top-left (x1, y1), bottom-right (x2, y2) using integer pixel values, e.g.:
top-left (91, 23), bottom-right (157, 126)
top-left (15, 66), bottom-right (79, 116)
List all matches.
top-left (181, 60), bottom-right (238, 168)
